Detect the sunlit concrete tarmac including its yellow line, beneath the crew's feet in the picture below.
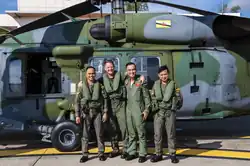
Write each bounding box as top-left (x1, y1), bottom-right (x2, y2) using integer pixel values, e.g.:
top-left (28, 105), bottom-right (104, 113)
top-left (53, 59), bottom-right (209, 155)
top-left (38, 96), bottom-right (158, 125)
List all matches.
top-left (0, 139), bottom-right (250, 166)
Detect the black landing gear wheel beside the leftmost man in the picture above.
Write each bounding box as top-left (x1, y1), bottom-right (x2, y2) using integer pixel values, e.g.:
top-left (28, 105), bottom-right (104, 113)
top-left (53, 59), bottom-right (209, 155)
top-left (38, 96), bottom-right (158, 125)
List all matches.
top-left (51, 121), bottom-right (81, 152)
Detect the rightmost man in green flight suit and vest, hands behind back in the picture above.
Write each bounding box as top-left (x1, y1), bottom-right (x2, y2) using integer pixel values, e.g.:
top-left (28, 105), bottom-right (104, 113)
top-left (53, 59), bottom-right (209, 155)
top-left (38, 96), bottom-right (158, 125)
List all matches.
top-left (151, 65), bottom-right (179, 163)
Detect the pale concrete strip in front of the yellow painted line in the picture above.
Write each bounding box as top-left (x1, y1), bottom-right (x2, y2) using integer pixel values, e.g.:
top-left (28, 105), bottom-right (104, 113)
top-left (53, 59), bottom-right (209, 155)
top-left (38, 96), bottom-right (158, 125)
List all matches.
top-left (0, 155), bottom-right (250, 166)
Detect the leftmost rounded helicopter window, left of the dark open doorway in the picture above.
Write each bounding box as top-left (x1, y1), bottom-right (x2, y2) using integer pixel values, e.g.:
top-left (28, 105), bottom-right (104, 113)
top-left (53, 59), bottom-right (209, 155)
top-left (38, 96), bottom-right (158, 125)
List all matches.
top-left (9, 59), bottom-right (22, 93)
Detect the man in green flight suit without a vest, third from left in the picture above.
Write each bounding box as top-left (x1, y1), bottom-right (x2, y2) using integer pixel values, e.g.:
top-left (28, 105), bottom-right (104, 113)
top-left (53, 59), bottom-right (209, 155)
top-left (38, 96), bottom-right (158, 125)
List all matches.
top-left (125, 62), bottom-right (151, 163)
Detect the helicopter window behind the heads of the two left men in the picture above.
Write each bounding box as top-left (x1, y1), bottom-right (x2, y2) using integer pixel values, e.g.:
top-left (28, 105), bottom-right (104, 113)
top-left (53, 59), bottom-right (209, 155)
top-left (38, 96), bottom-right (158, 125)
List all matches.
top-left (89, 57), bottom-right (120, 79)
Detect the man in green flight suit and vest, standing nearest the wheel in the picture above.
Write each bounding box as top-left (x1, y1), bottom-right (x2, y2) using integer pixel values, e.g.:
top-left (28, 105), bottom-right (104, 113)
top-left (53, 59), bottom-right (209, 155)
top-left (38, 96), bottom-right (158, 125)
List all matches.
top-left (75, 66), bottom-right (108, 163)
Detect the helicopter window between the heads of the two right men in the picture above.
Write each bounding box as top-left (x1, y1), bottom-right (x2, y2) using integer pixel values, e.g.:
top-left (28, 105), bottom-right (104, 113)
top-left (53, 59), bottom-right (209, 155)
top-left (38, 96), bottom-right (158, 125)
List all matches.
top-left (131, 56), bottom-right (160, 88)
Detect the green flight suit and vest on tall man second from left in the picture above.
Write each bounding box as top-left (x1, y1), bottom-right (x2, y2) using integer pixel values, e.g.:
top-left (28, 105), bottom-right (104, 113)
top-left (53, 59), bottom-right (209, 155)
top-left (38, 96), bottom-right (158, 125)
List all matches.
top-left (100, 72), bottom-right (128, 158)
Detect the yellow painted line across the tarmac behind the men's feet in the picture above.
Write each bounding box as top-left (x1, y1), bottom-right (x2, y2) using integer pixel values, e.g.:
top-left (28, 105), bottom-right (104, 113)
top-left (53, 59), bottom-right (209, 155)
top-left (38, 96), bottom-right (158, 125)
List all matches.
top-left (0, 147), bottom-right (250, 160)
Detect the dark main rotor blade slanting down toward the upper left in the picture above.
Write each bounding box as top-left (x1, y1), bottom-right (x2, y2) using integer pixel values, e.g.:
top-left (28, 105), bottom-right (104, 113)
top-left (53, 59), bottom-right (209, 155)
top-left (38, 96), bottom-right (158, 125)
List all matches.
top-left (6, 1), bottom-right (100, 36)
